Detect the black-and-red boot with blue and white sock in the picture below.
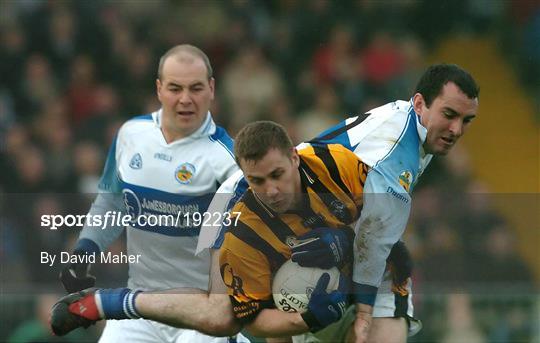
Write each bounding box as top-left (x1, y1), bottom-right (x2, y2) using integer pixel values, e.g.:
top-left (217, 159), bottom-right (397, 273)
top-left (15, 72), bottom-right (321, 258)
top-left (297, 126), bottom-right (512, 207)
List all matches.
top-left (50, 288), bottom-right (140, 336)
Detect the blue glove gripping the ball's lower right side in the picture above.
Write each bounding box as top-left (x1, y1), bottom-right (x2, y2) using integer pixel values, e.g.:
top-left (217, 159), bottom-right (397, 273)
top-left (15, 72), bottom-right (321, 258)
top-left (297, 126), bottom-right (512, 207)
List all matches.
top-left (302, 273), bottom-right (347, 332)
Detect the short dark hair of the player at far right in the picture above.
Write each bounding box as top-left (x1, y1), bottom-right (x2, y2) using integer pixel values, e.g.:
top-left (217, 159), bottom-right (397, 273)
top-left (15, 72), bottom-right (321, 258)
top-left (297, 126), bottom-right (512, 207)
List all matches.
top-left (415, 63), bottom-right (480, 107)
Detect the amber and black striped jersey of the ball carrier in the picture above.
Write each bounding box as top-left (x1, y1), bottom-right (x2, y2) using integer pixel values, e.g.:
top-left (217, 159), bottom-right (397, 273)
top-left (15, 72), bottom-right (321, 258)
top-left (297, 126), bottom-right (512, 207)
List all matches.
top-left (220, 144), bottom-right (368, 321)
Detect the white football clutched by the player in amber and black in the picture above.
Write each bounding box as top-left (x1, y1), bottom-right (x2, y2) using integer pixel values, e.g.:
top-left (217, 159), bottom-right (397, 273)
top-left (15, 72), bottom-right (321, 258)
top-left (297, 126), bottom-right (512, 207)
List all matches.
top-left (272, 260), bottom-right (339, 313)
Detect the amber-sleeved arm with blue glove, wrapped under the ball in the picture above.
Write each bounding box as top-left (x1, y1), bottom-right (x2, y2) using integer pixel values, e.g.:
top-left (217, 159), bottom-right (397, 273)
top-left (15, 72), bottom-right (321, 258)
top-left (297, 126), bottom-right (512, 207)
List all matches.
top-left (220, 242), bottom-right (347, 337)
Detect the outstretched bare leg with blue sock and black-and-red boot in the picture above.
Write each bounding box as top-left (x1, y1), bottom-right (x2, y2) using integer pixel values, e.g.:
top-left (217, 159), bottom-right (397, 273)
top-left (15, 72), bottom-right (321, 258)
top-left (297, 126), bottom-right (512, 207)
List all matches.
top-left (51, 252), bottom-right (241, 336)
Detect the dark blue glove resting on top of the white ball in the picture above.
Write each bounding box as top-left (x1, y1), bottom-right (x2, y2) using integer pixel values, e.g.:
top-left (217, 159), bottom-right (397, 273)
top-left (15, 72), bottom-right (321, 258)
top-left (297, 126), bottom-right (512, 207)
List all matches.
top-left (291, 227), bottom-right (354, 269)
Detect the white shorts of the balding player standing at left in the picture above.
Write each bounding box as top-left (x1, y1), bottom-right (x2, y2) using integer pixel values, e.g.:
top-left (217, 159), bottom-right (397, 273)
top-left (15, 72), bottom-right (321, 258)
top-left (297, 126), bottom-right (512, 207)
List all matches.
top-left (99, 319), bottom-right (249, 343)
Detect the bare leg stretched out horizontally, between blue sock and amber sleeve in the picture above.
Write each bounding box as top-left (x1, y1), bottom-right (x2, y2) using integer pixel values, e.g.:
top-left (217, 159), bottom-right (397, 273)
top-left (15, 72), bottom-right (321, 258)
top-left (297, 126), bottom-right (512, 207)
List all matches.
top-left (135, 289), bottom-right (241, 336)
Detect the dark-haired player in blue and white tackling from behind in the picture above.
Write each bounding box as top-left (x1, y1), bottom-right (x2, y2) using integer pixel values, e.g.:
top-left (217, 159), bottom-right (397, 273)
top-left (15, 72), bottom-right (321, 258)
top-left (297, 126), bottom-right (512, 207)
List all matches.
top-left (53, 64), bottom-right (478, 342)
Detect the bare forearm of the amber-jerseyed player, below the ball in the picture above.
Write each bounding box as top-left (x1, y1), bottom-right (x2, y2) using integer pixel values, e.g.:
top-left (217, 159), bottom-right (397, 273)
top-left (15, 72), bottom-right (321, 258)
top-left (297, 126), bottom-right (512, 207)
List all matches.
top-left (246, 309), bottom-right (309, 337)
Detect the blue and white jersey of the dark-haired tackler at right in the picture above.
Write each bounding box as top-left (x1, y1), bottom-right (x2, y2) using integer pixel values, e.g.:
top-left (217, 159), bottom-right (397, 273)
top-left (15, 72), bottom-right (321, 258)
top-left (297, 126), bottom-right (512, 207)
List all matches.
top-left (197, 100), bottom-right (432, 291)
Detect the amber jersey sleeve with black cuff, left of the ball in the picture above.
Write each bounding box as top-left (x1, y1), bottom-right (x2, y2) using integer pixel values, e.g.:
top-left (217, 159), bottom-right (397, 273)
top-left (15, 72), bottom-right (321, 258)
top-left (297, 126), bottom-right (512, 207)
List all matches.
top-left (220, 232), bottom-right (274, 324)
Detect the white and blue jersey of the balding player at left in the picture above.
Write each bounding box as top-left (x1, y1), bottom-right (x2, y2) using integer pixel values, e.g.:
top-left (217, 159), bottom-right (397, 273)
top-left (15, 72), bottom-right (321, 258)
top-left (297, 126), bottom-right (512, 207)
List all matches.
top-left (79, 110), bottom-right (238, 290)
